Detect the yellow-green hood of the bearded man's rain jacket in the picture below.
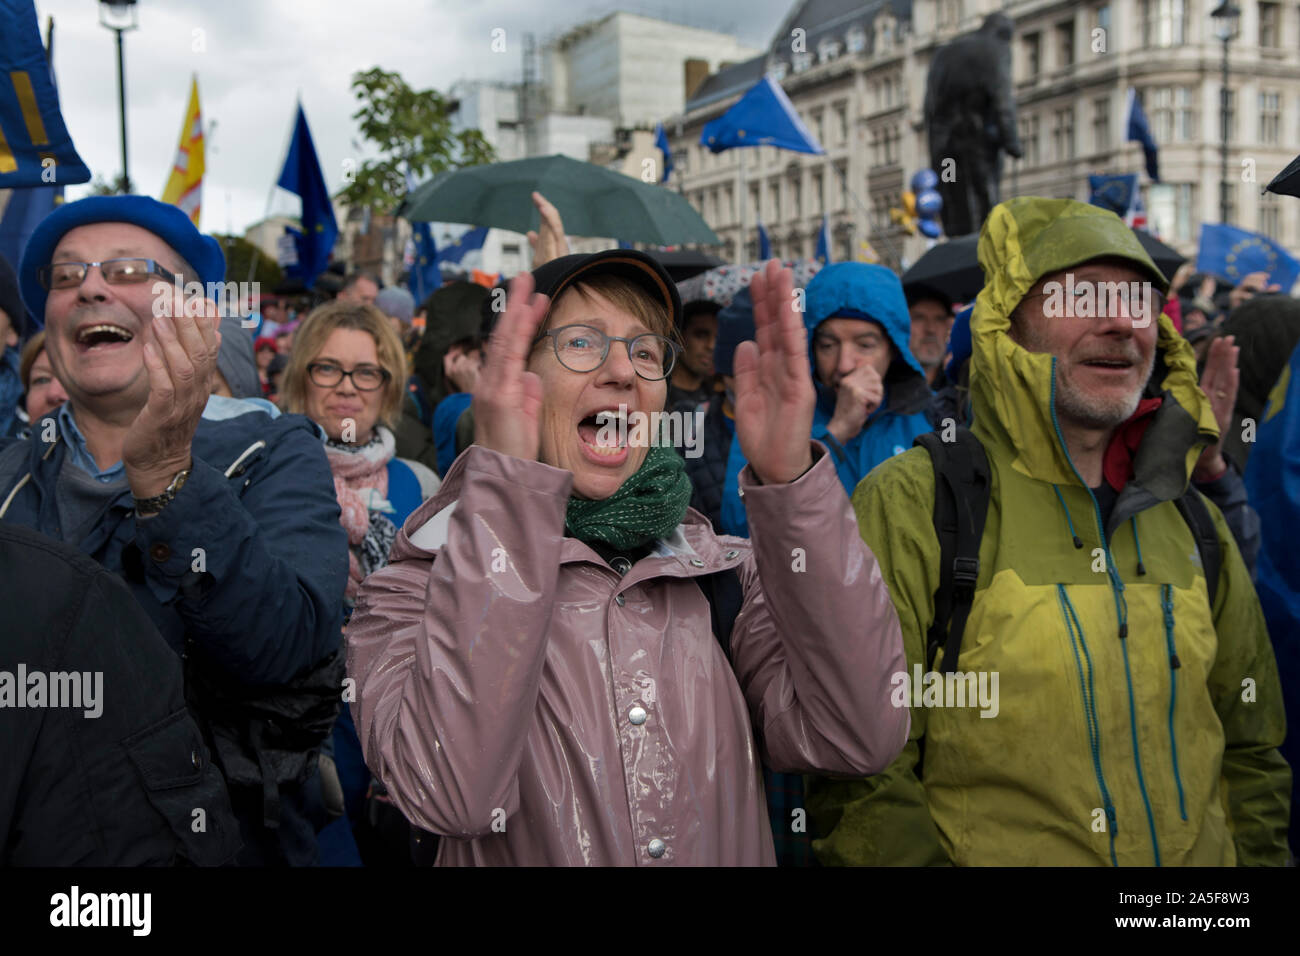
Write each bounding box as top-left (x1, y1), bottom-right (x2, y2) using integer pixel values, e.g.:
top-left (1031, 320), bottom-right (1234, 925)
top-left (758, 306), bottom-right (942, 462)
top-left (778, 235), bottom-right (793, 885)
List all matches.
top-left (971, 198), bottom-right (1218, 499)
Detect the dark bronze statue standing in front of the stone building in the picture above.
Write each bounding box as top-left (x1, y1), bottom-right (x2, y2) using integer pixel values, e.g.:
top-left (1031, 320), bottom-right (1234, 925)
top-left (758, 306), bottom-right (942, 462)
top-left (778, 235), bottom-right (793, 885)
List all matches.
top-left (926, 13), bottom-right (1022, 235)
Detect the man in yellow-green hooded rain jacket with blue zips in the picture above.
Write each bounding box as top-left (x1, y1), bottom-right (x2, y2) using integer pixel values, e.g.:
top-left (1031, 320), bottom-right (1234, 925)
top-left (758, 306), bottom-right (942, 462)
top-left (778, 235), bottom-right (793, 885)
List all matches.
top-left (807, 198), bottom-right (1291, 866)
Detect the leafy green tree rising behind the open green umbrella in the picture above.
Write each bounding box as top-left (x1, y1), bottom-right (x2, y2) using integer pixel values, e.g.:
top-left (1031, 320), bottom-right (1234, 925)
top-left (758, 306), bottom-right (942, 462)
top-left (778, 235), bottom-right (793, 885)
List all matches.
top-left (338, 66), bottom-right (495, 213)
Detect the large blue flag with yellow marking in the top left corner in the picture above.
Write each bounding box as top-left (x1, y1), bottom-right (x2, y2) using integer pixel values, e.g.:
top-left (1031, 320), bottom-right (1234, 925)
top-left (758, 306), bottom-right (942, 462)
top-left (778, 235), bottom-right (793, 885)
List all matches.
top-left (0, 0), bottom-right (90, 189)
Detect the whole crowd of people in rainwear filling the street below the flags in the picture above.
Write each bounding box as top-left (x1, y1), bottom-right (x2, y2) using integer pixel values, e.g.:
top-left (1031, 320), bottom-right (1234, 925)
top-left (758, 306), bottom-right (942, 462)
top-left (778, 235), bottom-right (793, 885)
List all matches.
top-left (0, 183), bottom-right (1300, 866)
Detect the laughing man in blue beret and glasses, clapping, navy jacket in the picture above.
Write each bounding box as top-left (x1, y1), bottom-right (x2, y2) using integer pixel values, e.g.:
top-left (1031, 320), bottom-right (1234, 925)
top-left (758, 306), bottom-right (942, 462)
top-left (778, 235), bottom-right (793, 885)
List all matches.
top-left (0, 196), bottom-right (347, 865)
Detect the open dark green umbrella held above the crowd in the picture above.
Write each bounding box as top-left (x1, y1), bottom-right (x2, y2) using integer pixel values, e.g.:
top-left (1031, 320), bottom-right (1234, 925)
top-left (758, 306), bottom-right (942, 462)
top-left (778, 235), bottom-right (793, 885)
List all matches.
top-left (397, 156), bottom-right (722, 246)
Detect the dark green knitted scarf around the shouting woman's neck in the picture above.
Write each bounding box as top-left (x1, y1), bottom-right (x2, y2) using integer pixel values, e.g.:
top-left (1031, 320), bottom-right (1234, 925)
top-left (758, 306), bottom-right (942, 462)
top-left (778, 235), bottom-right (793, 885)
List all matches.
top-left (564, 445), bottom-right (690, 550)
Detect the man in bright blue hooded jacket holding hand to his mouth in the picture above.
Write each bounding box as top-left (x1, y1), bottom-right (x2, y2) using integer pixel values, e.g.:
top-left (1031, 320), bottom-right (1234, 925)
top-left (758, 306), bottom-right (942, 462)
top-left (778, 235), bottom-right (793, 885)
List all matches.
top-left (723, 263), bottom-right (931, 537)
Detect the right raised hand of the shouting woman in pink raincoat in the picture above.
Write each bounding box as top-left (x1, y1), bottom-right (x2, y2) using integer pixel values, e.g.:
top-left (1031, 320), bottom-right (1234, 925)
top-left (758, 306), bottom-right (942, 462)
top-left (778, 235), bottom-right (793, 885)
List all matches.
top-left (735, 259), bottom-right (816, 484)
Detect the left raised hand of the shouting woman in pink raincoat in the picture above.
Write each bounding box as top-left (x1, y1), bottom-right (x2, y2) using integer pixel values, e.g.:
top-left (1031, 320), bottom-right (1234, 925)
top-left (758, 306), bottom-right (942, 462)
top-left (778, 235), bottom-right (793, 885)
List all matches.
top-left (472, 272), bottom-right (550, 462)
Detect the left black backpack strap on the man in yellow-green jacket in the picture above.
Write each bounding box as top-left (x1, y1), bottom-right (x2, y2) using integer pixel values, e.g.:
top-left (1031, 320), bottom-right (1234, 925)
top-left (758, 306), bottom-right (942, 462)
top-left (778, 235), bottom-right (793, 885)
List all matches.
top-left (913, 428), bottom-right (992, 674)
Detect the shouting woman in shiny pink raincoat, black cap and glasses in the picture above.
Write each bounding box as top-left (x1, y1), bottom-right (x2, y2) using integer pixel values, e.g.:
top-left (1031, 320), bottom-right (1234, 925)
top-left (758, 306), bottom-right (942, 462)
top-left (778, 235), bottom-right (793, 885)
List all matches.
top-left (347, 250), bottom-right (909, 866)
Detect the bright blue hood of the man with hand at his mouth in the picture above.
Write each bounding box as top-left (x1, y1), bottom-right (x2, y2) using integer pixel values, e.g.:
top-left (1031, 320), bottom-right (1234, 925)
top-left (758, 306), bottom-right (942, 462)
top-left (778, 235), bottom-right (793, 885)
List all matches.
top-left (803, 263), bottom-right (930, 415)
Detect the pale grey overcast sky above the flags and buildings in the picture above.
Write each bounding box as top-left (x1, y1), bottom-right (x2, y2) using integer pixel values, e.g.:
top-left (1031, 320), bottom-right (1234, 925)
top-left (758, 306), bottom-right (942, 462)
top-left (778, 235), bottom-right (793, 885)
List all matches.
top-left (35, 0), bottom-right (796, 233)
